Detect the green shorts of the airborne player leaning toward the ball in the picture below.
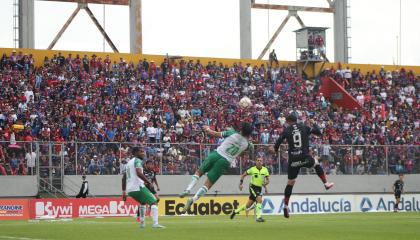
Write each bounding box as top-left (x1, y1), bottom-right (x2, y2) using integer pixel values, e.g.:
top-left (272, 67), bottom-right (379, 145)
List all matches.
top-left (200, 151), bottom-right (230, 184)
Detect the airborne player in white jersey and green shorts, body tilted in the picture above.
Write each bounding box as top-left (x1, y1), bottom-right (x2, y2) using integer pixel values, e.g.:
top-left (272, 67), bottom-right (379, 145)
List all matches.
top-left (179, 122), bottom-right (254, 213)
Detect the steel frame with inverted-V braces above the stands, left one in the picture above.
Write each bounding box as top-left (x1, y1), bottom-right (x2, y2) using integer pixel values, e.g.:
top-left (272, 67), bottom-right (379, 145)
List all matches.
top-left (19, 0), bottom-right (143, 54)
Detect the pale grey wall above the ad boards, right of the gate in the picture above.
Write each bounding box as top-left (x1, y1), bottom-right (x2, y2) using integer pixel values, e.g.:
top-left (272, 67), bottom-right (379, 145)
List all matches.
top-left (61, 174), bottom-right (420, 196)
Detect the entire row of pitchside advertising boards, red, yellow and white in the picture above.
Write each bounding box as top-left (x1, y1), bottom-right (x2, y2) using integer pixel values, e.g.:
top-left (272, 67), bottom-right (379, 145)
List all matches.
top-left (26, 194), bottom-right (420, 220)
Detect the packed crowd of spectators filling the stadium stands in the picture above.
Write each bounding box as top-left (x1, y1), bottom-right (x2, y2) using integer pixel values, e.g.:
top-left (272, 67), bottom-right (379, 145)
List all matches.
top-left (0, 49), bottom-right (420, 175)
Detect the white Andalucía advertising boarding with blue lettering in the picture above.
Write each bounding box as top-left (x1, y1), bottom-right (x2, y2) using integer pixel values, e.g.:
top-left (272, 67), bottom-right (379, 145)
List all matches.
top-left (262, 194), bottom-right (420, 215)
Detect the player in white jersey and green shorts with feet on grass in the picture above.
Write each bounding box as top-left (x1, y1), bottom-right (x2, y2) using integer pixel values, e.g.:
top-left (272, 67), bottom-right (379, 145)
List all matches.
top-left (122, 147), bottom-right (164, 228)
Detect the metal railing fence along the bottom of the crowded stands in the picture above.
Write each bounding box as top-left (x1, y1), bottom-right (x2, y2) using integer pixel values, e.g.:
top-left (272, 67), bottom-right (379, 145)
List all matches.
top-left (0, 142), bottom-right (420, 176)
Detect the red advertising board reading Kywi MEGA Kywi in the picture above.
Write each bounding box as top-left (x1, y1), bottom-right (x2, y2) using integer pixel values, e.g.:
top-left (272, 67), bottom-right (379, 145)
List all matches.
top-left (30, 198), bottom-right (138, 219)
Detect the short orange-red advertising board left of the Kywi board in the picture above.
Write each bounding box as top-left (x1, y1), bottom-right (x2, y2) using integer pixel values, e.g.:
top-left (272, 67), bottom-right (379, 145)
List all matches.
top-left (0, 199), bottom-right (29, 220)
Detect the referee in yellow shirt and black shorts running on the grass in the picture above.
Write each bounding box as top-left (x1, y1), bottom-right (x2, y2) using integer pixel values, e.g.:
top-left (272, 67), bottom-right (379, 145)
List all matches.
top-left (230, 157), bottom-right (270, 222)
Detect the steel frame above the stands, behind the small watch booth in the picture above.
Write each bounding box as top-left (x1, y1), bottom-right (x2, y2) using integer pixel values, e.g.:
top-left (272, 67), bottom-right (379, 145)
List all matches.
top-left (239, 0), bottom-right (350, 63)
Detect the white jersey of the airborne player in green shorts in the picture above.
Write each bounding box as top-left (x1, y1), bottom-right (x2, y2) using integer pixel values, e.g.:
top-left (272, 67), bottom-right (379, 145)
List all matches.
top-left (216, 130), bottom-right (252, 162)
